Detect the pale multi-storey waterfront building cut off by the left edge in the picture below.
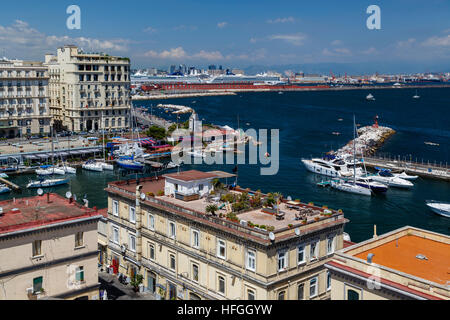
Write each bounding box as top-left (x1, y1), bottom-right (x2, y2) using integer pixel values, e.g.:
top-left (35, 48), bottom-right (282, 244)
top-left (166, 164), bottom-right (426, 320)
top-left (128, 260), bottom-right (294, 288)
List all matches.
top-left (0, 59), bottom-right (51, 138)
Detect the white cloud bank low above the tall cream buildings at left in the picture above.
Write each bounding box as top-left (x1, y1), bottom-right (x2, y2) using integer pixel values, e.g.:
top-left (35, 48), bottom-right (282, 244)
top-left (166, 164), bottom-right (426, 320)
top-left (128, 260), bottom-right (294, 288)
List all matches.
top-left (0, 20), bottom-right (130, 59)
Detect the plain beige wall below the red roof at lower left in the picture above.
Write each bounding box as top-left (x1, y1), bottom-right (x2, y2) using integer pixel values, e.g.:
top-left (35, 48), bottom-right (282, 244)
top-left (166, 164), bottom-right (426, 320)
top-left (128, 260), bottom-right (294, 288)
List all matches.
top-left (0, 220), bottom-right (98, 300)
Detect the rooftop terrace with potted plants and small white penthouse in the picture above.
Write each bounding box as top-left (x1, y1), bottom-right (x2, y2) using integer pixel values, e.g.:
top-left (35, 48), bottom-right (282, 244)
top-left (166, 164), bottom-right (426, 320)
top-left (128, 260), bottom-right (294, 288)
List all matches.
top-left (106, 170), bottom-right (348, 245)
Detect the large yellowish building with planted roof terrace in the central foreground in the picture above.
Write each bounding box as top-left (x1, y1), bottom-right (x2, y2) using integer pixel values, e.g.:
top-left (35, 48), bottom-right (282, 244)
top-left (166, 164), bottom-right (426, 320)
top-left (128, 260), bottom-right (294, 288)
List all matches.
top-left (106, 170), bottom-right (348, 300)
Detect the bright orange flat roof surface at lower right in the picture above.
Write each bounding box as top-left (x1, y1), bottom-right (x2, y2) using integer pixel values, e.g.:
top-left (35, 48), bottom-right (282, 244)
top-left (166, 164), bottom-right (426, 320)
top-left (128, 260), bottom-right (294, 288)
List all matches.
top-left (355, 235), bottom-right (450, 285)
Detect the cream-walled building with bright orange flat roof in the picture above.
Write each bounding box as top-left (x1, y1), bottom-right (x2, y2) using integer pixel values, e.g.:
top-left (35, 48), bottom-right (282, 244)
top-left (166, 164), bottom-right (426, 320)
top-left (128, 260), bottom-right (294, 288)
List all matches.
top-left (325, 227), bottom-right (450, 300)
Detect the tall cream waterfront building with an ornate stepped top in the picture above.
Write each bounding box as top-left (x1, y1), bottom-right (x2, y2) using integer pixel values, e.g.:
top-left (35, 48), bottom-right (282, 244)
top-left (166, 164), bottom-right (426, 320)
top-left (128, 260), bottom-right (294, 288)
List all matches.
top-left (45, 46), bottom-right (131, 131)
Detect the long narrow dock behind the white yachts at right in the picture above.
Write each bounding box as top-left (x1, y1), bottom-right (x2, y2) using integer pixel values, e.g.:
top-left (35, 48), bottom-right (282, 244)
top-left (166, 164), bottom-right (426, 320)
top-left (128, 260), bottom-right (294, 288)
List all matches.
top-left (364, 156), bottom-right (450, 182)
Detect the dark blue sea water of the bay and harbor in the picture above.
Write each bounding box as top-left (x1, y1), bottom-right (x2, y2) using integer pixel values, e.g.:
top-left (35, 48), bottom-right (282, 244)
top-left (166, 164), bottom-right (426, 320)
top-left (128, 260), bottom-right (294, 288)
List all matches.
top-left (0, 88), bottom-right (450, 241)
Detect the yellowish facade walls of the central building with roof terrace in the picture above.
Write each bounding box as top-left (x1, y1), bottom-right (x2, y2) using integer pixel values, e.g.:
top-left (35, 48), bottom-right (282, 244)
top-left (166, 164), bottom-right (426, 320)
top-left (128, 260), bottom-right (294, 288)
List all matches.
top-left (108, 192), bottom-right (342, 300)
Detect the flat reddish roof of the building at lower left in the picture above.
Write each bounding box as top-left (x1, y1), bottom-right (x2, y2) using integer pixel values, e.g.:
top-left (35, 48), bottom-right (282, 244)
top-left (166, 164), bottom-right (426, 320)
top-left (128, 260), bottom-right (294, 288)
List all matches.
top-left (0, 194), bottom-right (99, 236)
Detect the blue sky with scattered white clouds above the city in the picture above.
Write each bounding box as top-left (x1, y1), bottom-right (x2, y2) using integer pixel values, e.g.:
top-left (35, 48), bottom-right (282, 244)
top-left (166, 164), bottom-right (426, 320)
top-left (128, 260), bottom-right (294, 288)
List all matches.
top-left (0, 0), bottom-right (450, 72)
